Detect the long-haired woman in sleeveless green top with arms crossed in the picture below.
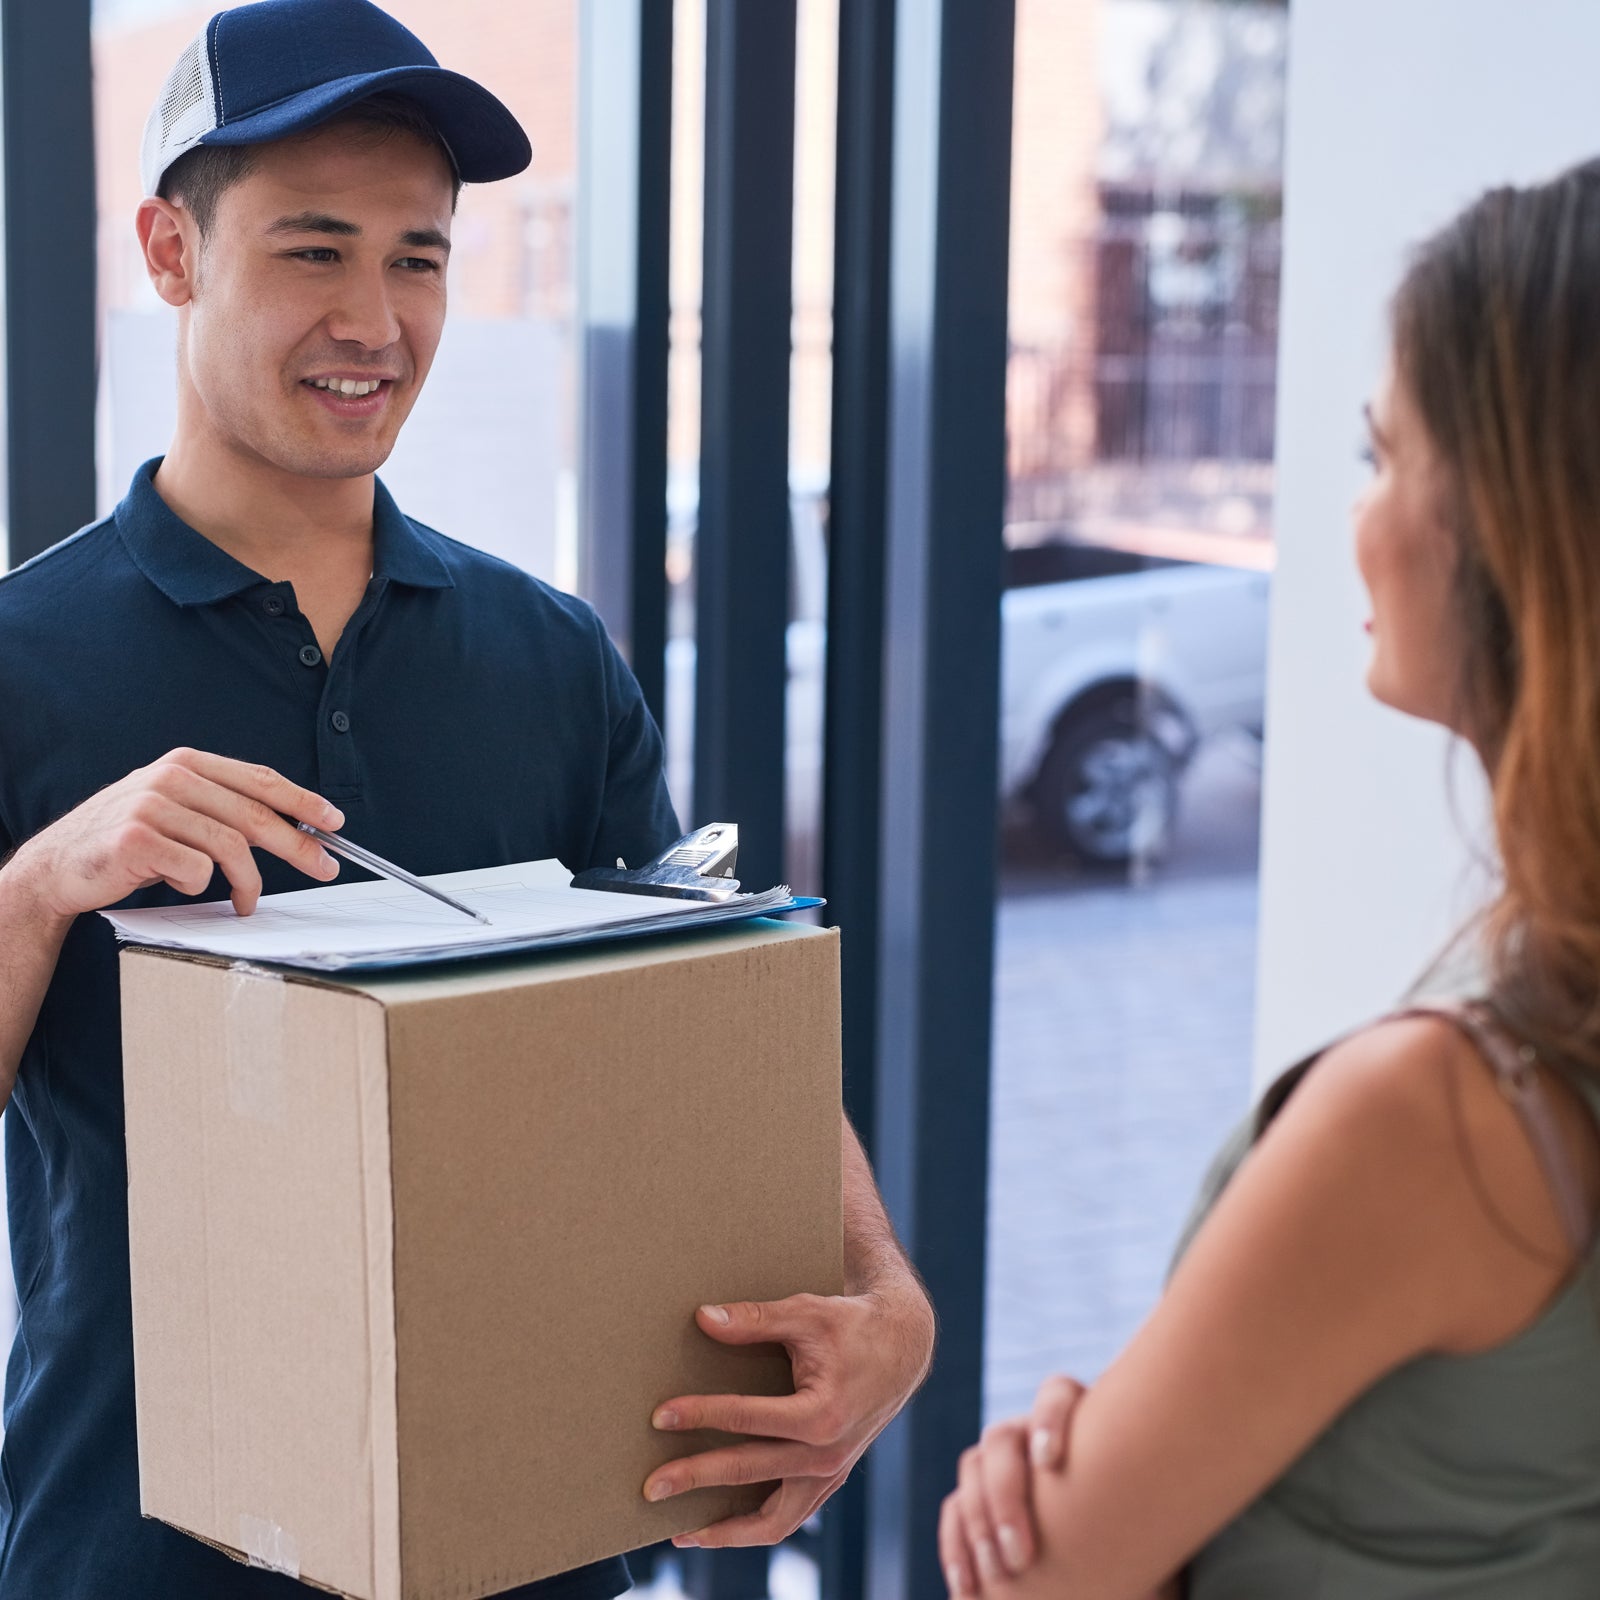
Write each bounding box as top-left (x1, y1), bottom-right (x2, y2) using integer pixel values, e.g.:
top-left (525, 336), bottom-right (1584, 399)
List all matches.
top-left (941, 162), bottom-right (1600, 1600)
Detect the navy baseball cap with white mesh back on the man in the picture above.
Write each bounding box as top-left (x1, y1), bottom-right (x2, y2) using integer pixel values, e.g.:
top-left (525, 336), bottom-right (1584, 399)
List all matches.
top-left (139, 0), bottom-right (533, 195)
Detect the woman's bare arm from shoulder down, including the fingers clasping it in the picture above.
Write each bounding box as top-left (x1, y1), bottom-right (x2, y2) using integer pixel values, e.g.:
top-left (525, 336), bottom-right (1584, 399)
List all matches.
top-left (941, 1019), bottom-right (1595, 1600)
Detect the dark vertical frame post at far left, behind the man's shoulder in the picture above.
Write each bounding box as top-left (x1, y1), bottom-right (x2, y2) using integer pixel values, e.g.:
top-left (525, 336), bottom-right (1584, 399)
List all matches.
top-left (0, 0), bottom-right (96, 566)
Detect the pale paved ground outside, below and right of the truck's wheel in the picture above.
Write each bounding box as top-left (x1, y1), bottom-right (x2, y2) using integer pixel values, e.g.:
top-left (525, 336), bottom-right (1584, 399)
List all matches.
top-left (986, 732), bottom-right (1261, 1416)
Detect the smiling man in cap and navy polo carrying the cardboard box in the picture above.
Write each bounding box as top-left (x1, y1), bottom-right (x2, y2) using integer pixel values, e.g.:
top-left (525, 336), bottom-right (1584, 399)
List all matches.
top-left (0, 0), bottom-right (933, 1600)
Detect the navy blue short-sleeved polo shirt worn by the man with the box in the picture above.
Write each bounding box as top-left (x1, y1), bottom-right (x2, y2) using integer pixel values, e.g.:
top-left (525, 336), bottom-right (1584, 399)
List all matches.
top-left (0, 461), bottom-right (677, 1600)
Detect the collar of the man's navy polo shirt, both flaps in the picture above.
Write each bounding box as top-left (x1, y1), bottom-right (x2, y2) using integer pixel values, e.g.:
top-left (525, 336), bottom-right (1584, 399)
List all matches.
top-left (112, 456), bottom-right (454, 605)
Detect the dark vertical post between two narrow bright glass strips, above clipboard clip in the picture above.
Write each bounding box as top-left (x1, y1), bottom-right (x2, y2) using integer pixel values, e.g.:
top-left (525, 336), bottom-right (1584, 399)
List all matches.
top-left (694, 0), bottom-right (797, 888)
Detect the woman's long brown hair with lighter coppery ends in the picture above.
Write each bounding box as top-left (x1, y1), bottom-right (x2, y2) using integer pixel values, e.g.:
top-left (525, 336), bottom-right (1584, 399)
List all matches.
top-left (1394, 162), bottom-right (1600, 1077)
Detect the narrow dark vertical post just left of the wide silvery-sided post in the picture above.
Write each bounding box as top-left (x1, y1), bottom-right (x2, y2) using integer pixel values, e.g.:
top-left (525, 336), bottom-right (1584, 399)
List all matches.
top-left (821, 0), bottom-right (894, 1600)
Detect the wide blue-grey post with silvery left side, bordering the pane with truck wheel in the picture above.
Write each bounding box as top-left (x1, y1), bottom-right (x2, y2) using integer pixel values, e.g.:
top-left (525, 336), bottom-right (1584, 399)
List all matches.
top-left (869, 0), bottom-right (1014, 1600)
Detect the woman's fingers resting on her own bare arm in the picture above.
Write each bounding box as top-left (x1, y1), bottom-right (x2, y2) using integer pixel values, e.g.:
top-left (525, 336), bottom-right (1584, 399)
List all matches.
top-left (939, 1378), bottom-right (1085, 1597)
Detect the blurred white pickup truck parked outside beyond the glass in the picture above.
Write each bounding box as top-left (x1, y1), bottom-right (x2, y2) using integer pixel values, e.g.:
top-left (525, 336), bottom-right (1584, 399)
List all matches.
top-left (667, 496), bottom-right (1270, 867)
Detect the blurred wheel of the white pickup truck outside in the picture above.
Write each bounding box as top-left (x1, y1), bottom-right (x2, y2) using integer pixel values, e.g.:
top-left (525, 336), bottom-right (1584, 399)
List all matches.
top-left (1034, 698), bottom-right (1181, 867)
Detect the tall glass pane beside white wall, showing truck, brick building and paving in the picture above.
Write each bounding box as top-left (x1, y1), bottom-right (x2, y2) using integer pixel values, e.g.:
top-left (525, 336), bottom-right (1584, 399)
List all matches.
top-left (986, 0), bottom-right (1286, 1414)
